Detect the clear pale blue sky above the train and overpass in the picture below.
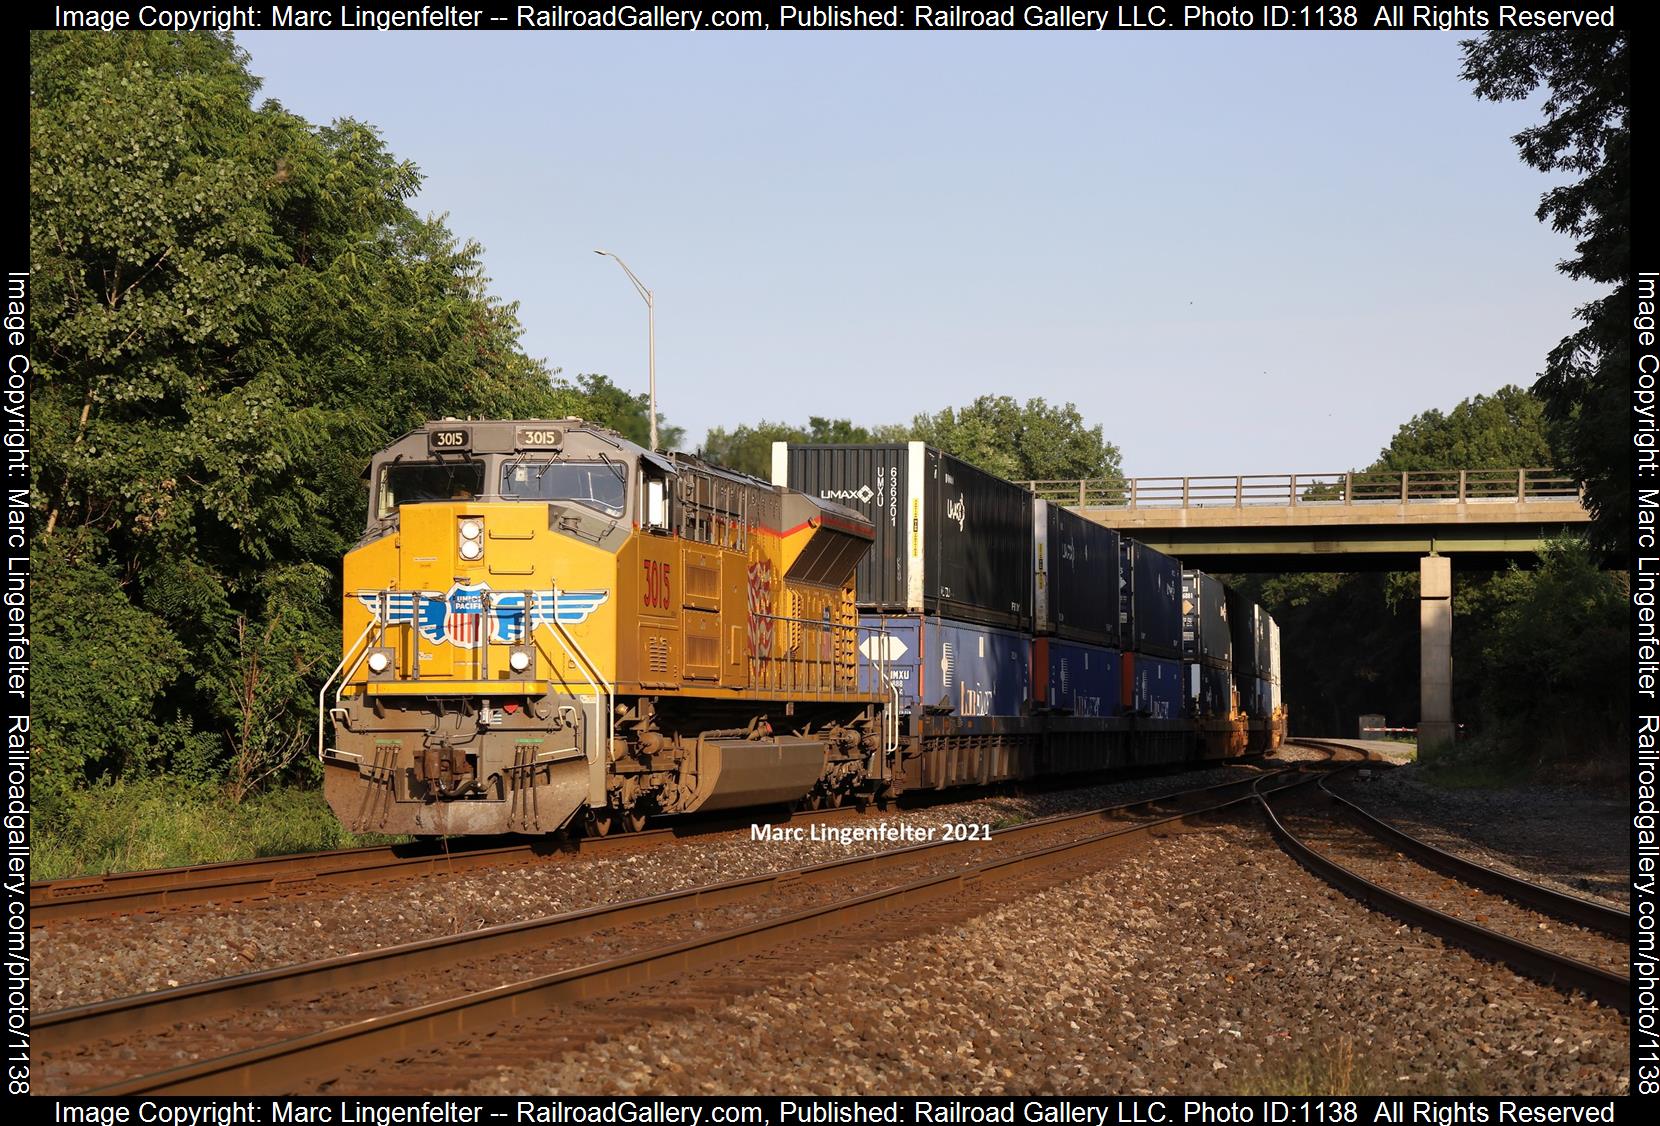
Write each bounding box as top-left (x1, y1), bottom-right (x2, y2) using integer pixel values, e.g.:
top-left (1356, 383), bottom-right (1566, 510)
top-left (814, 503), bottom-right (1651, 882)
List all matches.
top-left (237, 32), bottom-right (1592, 475)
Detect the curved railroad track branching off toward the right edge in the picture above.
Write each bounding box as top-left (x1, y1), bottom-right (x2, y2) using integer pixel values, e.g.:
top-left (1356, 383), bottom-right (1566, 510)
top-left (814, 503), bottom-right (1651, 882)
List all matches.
top-left (1260, 781), bottom-right (1630, 1013)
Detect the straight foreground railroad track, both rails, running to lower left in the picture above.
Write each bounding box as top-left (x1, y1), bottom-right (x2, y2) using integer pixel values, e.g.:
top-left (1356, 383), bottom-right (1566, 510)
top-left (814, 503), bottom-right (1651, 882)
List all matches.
top-left (33, 771), bottom-right (1318, 1094)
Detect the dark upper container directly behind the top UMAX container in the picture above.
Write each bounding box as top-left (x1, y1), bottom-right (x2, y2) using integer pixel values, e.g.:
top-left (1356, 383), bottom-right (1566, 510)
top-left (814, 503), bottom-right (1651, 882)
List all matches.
top-left (1033, 498), bottom-right (1119, 648)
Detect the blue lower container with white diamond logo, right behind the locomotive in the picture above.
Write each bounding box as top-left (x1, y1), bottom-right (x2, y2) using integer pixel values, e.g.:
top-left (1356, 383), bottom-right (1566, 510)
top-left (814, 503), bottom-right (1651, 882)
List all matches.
top-left (858, 614), bottom-right (1031, 716)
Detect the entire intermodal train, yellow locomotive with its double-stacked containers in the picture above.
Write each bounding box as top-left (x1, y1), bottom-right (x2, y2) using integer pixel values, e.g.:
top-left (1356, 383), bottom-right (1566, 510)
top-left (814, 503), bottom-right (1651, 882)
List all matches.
top-left (317, 419), bottom-right (1285, 835)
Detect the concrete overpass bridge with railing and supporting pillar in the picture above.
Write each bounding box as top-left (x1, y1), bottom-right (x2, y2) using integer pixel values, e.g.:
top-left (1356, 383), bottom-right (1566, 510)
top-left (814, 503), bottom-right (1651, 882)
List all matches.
top-left (1026, 468), bottom-right (1590, 749)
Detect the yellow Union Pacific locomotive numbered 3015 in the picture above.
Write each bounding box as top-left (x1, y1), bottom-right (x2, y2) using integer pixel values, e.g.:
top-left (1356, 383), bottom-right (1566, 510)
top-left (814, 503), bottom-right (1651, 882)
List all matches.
top-left (317, 419), bottom-right (896, 835)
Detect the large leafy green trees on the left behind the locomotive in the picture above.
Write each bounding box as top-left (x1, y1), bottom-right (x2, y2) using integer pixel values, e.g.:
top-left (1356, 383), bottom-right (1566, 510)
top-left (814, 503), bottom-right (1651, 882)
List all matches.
top-left (30, 32), bottom-right (657, 803)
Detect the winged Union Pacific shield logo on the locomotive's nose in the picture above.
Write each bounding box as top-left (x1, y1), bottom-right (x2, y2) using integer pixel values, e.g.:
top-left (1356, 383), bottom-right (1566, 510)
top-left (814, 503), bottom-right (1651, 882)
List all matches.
top-left (357, 583), bottom-right (611, 649)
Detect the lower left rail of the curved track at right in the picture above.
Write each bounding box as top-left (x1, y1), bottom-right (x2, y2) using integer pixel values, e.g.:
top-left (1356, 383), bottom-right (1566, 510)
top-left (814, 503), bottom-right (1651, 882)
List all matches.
top-left (1257, 777), bottom-right (1632, 1013)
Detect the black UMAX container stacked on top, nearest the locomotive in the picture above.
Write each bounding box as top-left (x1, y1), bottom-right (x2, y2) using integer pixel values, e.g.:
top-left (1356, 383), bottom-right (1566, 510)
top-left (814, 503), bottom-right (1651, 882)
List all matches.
top-left (772, 442), bottom-right (1033, 629)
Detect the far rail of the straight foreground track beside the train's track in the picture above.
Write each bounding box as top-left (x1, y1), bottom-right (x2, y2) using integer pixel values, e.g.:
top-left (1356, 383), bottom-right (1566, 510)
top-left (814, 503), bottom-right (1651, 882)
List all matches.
top-left (33, 777), bottom-right (1281, 1056)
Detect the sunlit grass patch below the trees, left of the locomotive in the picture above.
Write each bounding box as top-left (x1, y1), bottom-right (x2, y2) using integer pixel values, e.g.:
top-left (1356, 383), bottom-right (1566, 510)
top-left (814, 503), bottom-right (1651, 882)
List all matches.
top-left (28, 779), bottom-right (405, 880)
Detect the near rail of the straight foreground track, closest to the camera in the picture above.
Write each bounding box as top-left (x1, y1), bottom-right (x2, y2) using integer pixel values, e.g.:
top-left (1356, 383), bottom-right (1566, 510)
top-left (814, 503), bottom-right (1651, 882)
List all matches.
top-left (80, 771), bottom-right (1318, 1094)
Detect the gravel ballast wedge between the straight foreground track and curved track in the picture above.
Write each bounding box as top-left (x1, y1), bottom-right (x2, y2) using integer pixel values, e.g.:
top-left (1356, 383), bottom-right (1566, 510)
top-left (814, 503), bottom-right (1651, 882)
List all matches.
top-left (468, 820), bottom-right (1628, 1094)
